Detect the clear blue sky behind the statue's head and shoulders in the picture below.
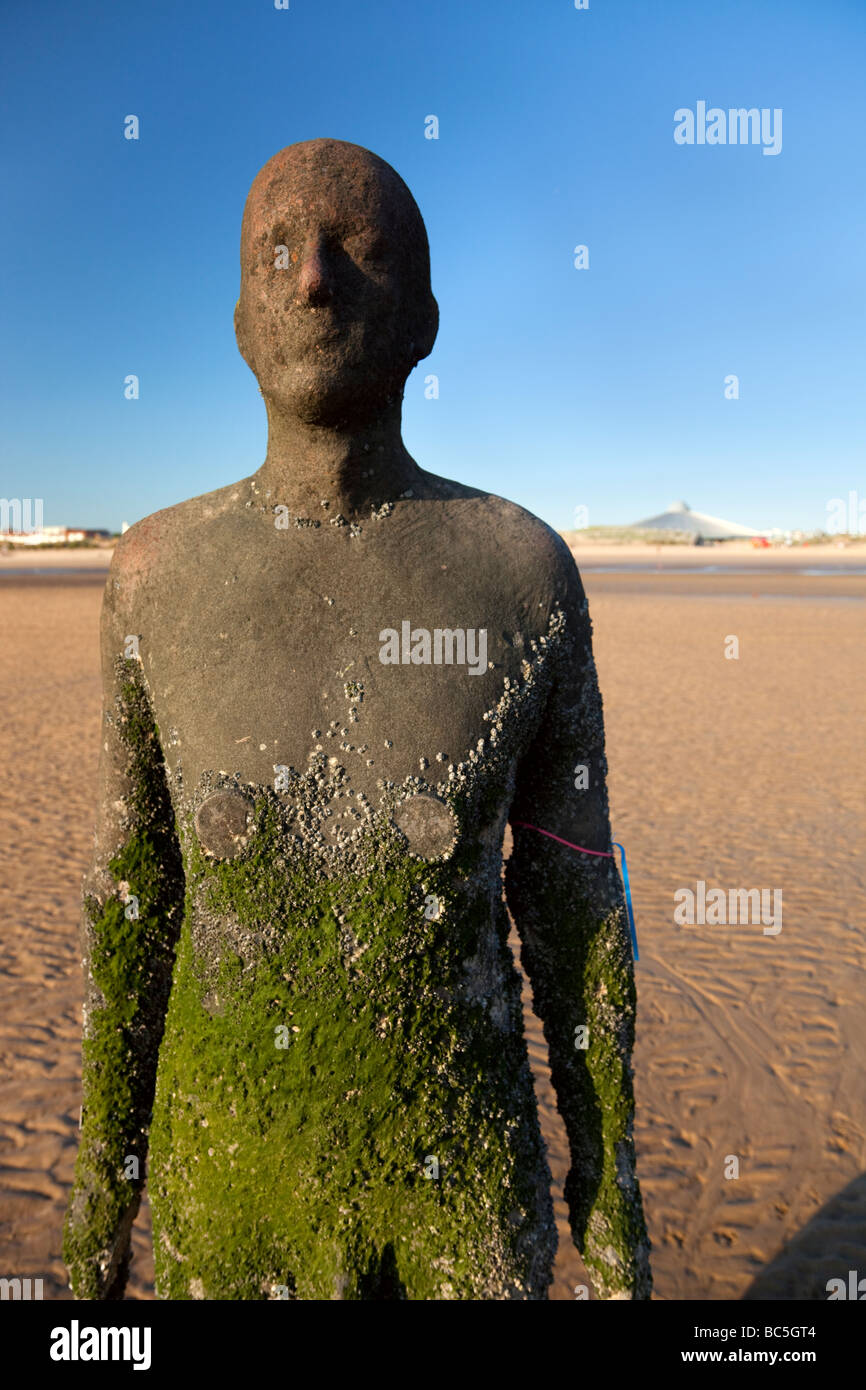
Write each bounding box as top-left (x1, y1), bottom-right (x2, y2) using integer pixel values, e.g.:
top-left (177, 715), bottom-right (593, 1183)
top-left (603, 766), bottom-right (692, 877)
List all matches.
top-left (0, 0), bottom-right (866, 530)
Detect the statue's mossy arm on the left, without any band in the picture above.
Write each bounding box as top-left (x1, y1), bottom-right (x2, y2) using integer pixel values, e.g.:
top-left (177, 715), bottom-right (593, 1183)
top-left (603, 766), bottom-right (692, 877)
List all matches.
top-left (63, 556), bottom-right (183, 1300)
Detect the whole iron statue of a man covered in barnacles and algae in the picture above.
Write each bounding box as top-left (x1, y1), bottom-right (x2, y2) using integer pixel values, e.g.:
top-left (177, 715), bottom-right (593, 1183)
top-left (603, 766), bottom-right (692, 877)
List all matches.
top-left (64, 140), bottom-right (651, 1300)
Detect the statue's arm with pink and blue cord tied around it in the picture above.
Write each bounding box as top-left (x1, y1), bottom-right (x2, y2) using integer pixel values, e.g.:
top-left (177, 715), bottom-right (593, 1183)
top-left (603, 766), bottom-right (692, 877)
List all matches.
top-left (506, 555), bottom-right (652, 1298)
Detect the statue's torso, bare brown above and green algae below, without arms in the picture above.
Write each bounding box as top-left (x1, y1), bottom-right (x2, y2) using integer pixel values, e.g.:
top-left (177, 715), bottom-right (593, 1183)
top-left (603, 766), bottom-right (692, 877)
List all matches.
top-left (115, 472), bottom-right (575, 1297)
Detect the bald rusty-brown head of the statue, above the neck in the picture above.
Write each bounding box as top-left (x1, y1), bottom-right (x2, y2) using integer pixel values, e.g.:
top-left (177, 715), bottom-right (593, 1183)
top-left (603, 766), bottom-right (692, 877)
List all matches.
top-left (235, 140), bottom-right (438, 425)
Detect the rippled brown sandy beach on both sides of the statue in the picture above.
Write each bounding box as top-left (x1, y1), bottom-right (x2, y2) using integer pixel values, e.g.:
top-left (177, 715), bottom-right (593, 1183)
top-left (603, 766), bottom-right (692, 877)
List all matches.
top-left (0, 545), bottom-right (866, 1300)
